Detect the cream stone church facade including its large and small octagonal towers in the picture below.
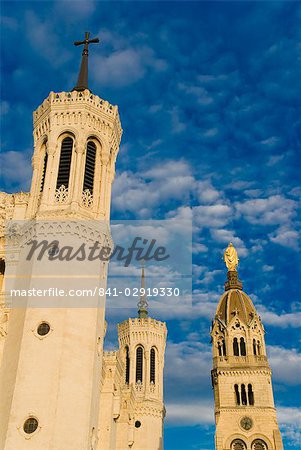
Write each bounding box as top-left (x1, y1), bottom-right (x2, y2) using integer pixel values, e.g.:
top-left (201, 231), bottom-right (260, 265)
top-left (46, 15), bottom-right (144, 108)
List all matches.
top-left (0, 89), bottom-right (166, 450)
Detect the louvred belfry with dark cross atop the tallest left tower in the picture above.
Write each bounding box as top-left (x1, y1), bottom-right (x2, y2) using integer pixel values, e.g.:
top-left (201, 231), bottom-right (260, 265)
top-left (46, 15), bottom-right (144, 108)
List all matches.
top-left (27, 33), bottom-right (122, 220)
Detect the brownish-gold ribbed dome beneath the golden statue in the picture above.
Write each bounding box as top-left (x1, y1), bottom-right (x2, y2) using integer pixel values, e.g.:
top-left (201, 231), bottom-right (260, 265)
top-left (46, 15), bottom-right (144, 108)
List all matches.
top-left (216, 289), bottom-right (257, 325)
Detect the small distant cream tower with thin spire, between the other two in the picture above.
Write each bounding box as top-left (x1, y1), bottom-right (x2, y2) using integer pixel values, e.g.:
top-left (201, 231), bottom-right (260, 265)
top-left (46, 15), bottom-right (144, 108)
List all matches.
top-left (98, 269), bottom-right (167, 450)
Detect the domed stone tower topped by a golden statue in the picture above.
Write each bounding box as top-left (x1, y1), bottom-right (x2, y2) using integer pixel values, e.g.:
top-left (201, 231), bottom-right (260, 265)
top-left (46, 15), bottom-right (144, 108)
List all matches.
top-left (211, 244), bottom-right (283, 450)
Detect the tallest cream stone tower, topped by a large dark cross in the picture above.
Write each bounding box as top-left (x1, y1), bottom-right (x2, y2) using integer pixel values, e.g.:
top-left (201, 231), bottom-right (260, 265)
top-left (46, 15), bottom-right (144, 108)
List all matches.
top-left (0, 33), bottom-right (122, 450)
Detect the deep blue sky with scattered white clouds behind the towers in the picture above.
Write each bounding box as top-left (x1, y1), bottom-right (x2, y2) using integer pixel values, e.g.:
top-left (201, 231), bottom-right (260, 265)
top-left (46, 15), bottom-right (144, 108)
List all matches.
top-left (1, 1), bottom-right (301, 450)
